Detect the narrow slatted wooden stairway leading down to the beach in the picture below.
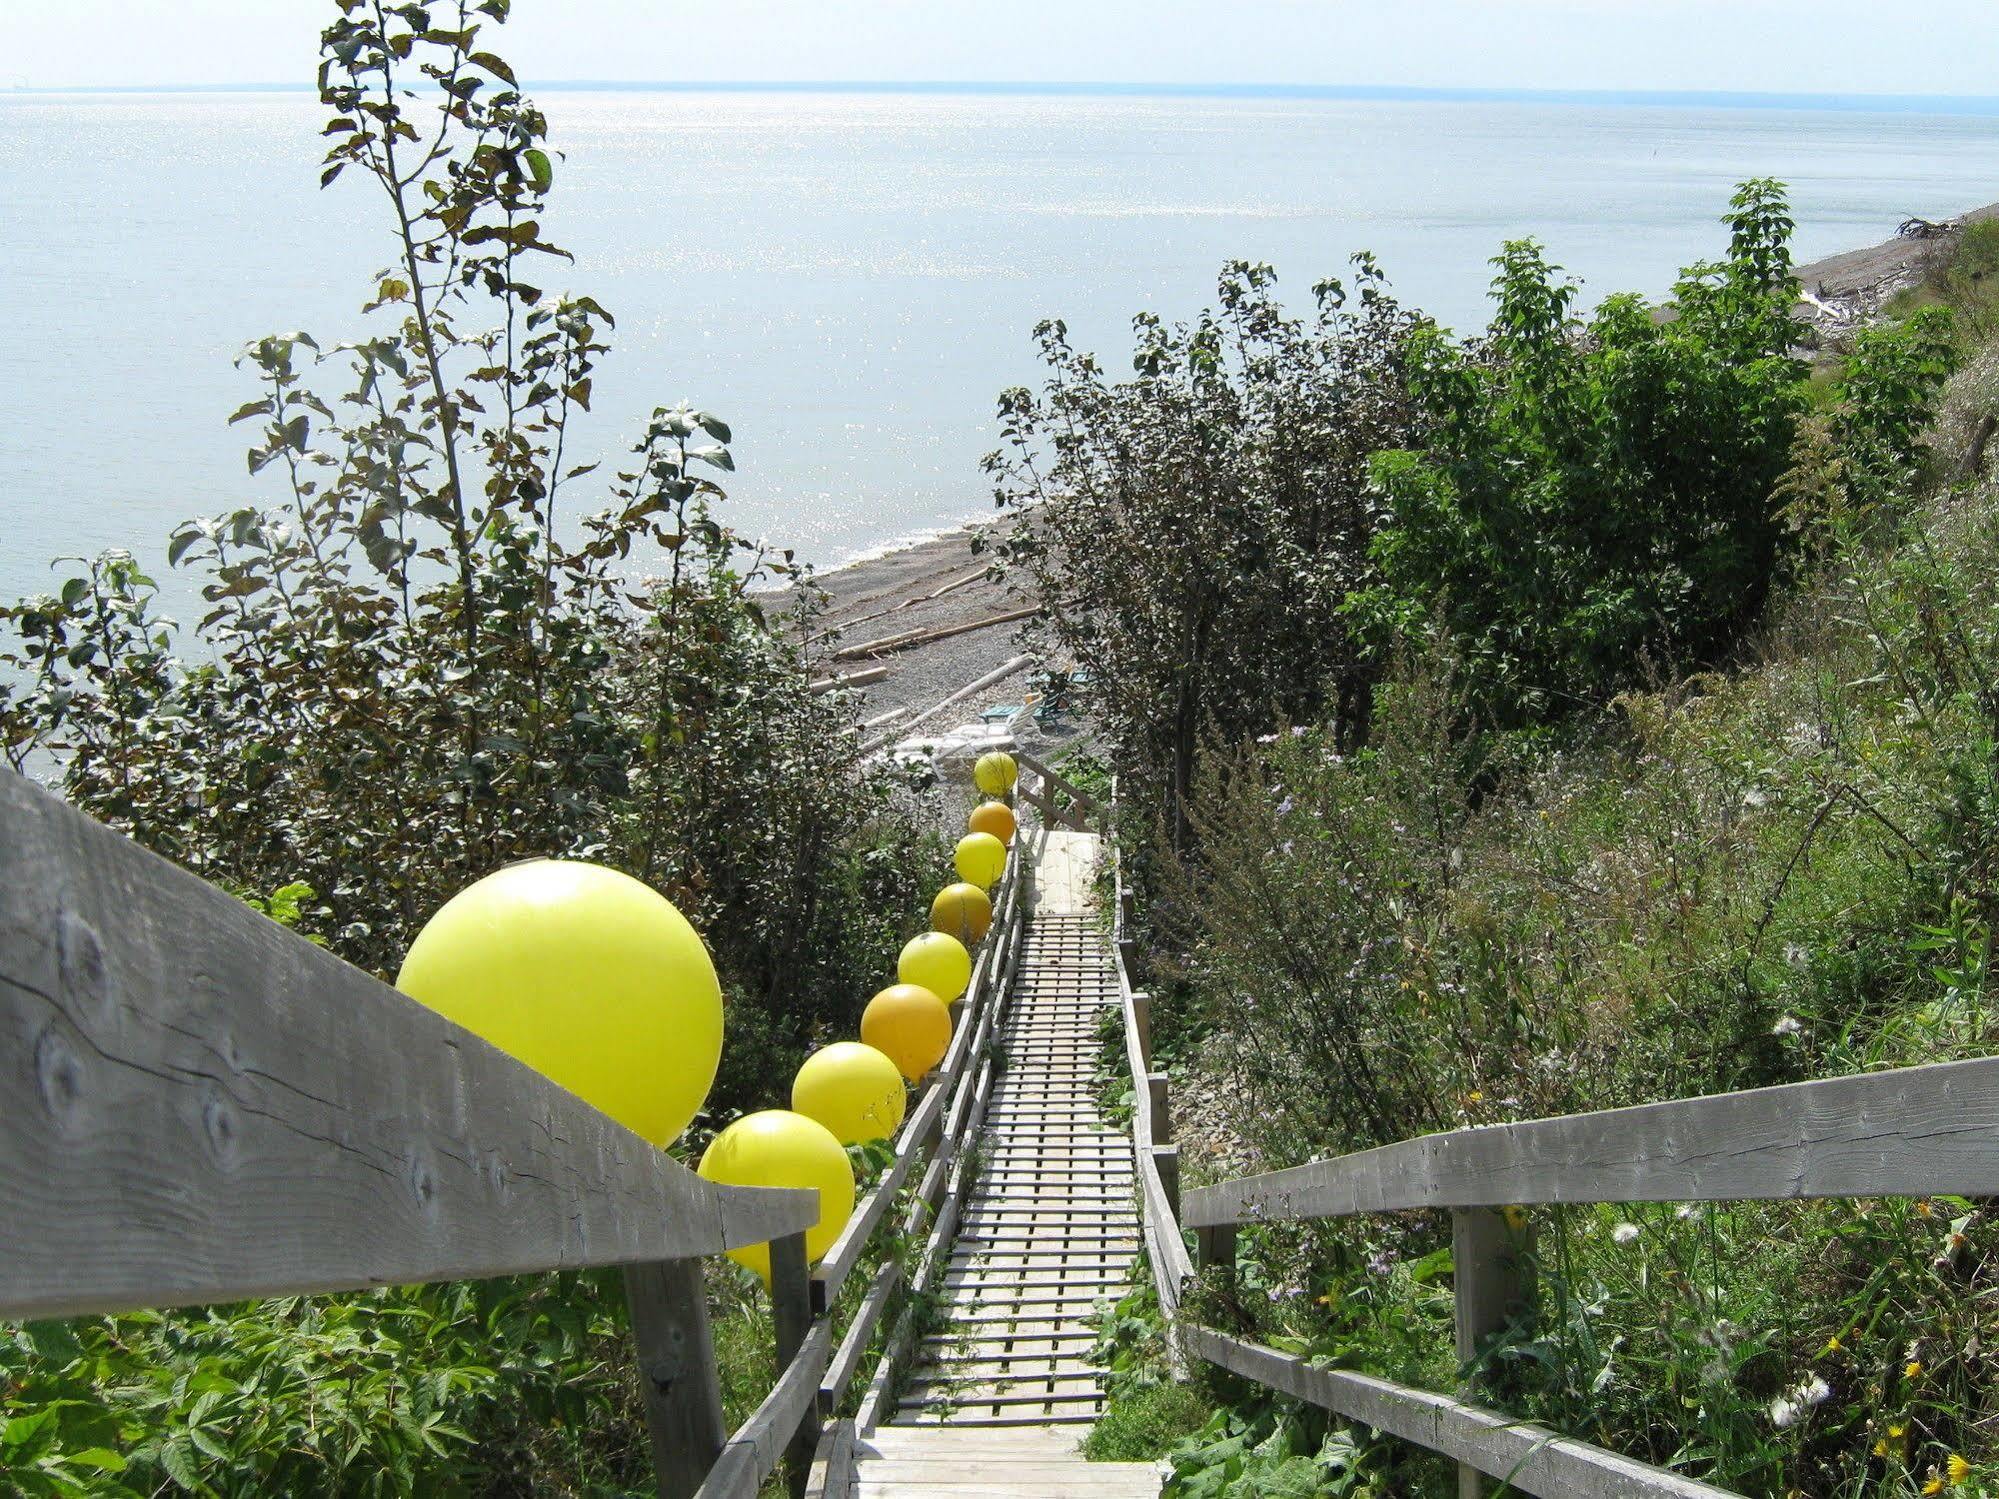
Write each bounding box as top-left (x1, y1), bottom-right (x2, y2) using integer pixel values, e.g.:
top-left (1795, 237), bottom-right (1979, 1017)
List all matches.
top-left (854, 831), bottom-right (1159, 1499)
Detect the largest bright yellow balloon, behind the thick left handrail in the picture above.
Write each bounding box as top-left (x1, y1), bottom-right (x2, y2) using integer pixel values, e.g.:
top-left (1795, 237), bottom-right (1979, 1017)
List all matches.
top-left (396, 859), bottom-right (722, 1145)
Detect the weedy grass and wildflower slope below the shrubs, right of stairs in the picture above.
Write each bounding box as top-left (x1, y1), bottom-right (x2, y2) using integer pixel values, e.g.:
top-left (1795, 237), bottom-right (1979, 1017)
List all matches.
top-left (1155, 354), bottom-right (1999, 1497)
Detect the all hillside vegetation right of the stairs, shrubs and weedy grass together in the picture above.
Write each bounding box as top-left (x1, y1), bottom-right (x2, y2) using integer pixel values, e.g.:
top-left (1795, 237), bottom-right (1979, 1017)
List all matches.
top-left (998, 202), bottom-right (1999, 1499)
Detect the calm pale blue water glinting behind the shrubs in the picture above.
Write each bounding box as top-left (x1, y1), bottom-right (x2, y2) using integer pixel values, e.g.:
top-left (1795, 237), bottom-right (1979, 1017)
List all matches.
top-left (0, 92), bottom-right (1999, 598)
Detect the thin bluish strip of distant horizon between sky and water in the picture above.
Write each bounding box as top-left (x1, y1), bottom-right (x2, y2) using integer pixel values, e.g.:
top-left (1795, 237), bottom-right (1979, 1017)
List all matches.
top-left (11, 78), bottom-right (1999, 114)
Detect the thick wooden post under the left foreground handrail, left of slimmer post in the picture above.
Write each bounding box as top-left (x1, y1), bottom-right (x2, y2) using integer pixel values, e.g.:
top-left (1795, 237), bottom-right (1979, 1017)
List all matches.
top-left (624, 1259), bottom-right (730, 1499)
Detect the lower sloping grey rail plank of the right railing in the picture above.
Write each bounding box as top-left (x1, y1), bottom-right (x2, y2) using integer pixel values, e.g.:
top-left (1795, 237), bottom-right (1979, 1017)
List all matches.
top-left (1181, 1323), bottom-right (1727, 1499)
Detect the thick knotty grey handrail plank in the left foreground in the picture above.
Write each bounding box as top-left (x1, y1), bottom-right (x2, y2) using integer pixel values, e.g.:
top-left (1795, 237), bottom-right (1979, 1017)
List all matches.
top-left (0, 771), bottom-right (816, 1317)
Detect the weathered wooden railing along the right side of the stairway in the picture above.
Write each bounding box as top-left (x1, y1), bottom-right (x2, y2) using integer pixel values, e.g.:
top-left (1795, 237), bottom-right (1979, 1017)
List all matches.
top-left (1117, 811), bottom-right (1999, 1499)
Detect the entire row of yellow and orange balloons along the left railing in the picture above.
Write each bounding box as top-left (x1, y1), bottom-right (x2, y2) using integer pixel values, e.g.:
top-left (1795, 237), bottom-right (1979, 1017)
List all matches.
top-left (381, 753), bottom-right (1017, 1283)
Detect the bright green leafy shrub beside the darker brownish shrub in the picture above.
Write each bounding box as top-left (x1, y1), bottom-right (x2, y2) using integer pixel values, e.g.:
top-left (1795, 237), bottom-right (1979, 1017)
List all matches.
top-left (1363, 182), bottom-right (1805, 728)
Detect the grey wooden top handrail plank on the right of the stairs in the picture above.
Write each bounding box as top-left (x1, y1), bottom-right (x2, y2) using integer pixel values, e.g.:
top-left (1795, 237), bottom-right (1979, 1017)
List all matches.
top-left (1185, 1057), bottom-right (1999, 1227)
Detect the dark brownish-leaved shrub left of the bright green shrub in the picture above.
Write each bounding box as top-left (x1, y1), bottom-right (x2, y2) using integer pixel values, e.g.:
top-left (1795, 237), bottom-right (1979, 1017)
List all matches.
top-left (986, 258), bottom-right (1409, 847)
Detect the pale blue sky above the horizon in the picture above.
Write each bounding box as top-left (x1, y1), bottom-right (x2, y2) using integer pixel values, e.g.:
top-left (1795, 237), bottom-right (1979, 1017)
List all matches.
top-left (15, 0), bottom-right (1999, 94)
